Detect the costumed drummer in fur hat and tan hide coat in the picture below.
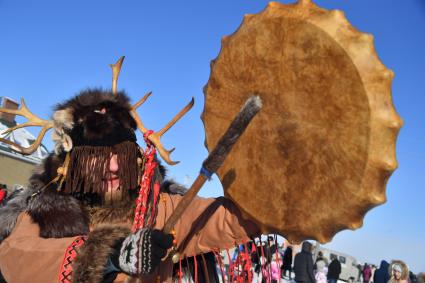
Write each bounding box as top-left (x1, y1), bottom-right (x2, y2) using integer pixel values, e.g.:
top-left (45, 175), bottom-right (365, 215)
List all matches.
top-left (0, 86), bottom-right (260, 283)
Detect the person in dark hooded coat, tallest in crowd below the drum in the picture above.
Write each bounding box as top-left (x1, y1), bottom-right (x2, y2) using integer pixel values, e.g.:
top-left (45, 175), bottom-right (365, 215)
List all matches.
top-left (294, 241), bottom-right (316, 283)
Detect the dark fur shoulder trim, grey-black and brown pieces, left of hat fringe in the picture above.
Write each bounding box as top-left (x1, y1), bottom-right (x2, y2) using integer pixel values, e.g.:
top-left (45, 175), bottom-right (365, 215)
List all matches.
top-left (0, 154), bottom-right (89, 242)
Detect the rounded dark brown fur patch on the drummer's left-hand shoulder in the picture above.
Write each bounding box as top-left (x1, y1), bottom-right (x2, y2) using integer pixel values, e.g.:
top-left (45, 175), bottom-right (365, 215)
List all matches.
top-left (27, 190), bottom-right (89, 238)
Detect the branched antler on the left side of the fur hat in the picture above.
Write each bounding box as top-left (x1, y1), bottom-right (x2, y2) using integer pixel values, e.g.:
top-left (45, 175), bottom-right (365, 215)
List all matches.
top-left (0, 98), bottom-right (53, 155)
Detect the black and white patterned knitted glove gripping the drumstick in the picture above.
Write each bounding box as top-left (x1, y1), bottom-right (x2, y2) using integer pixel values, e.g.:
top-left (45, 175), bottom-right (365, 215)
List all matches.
top-left (119, 228), bottom-right (173, 275)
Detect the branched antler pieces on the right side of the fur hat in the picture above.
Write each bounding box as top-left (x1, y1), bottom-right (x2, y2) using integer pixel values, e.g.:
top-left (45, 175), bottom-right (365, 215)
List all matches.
top-left (130, 95), bottom-right (195, 165)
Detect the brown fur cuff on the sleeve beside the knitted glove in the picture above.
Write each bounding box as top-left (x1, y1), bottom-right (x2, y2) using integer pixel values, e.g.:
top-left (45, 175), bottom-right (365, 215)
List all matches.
top-left (72, 225), bottom-right (130, 283)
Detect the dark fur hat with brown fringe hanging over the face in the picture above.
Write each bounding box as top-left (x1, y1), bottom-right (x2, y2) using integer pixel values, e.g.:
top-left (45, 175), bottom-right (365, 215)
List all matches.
top-left (47, 89), bottom-right (141, 200)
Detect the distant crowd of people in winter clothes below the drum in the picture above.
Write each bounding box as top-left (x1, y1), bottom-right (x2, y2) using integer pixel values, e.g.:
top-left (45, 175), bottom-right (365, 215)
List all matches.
top-left (224, 236), bottom-right (425, 283)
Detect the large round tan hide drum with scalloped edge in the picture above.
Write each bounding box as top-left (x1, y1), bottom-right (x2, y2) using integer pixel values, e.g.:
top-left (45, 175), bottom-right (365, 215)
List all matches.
top-left (202, 0), bottom-right (402, 242)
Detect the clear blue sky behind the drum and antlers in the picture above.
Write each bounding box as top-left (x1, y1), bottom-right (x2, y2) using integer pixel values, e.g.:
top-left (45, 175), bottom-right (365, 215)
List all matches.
top-left (0, 0), bottom-right (425, 272)
